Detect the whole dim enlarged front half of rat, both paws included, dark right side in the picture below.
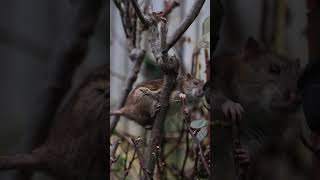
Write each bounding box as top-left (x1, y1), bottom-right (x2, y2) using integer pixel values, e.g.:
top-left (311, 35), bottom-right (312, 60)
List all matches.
top-left (210, 38), bottom-right (301, 176)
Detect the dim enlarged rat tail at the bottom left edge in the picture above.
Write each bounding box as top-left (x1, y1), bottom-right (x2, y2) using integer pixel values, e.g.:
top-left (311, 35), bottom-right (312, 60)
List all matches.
top-left (0, 154), bottom-right (41, 171)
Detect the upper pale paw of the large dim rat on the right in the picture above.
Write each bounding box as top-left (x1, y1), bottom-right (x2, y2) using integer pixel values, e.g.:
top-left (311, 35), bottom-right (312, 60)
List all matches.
top-left (222, 100), bottom-right (244, 122)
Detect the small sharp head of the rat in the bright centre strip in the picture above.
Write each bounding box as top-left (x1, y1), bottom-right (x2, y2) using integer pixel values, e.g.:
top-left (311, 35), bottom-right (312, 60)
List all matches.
top-left (181, 73), bottom-right (204, 100)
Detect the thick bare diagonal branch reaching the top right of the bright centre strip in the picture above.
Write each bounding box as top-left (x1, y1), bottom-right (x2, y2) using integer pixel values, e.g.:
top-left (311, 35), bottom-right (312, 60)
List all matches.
top-left (165, 0), bottom-right (205, 51)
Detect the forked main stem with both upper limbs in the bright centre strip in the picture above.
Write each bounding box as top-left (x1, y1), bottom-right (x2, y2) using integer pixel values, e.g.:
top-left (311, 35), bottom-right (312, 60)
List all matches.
top-left (127, 0), bottom-right (205, 180)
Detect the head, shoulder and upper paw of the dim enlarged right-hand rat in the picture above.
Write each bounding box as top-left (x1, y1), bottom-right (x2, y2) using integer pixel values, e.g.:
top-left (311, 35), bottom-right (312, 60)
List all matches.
top-left (212, 38), bottom-right (300, 123)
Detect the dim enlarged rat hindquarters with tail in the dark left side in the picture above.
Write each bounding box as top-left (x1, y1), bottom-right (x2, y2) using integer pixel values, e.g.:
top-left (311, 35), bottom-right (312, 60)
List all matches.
top-left (0, 65), bottom-right (110, 180)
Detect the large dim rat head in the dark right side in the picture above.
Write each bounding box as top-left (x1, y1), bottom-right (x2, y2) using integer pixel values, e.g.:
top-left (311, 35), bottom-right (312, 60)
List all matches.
top-left (237, 38), bottom-right (300, 113)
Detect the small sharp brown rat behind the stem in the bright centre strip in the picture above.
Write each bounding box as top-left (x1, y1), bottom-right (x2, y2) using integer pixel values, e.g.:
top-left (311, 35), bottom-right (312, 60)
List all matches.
top-left (110, 73), bottom-right (204, 129)
